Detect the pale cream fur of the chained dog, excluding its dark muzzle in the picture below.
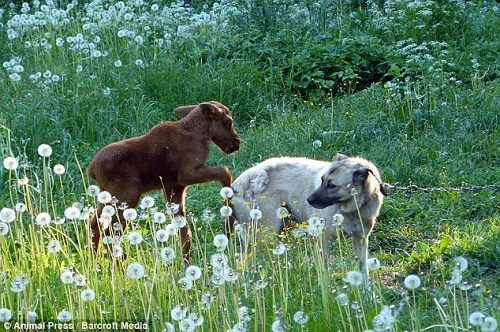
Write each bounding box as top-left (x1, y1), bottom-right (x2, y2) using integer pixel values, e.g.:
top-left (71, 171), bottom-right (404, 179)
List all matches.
top-left (232, 155), bottom-right (383, 276)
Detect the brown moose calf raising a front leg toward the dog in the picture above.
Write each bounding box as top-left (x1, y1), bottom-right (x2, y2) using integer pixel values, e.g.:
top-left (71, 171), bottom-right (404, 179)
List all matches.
top-left (89, 101), bottom-right (240, 261)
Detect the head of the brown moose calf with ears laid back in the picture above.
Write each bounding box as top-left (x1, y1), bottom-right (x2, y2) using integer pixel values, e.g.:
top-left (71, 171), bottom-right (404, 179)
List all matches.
top-left (174, 101), bottom-right (241, 154)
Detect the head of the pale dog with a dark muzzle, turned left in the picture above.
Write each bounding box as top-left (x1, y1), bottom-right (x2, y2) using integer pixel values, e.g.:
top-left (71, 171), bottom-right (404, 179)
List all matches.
top-left (307, 154), bottom-right (382, 212)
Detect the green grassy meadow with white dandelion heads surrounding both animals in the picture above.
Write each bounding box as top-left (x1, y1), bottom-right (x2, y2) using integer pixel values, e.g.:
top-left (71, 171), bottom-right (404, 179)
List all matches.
top-left (0, 0), bottom-right (500, 331)
